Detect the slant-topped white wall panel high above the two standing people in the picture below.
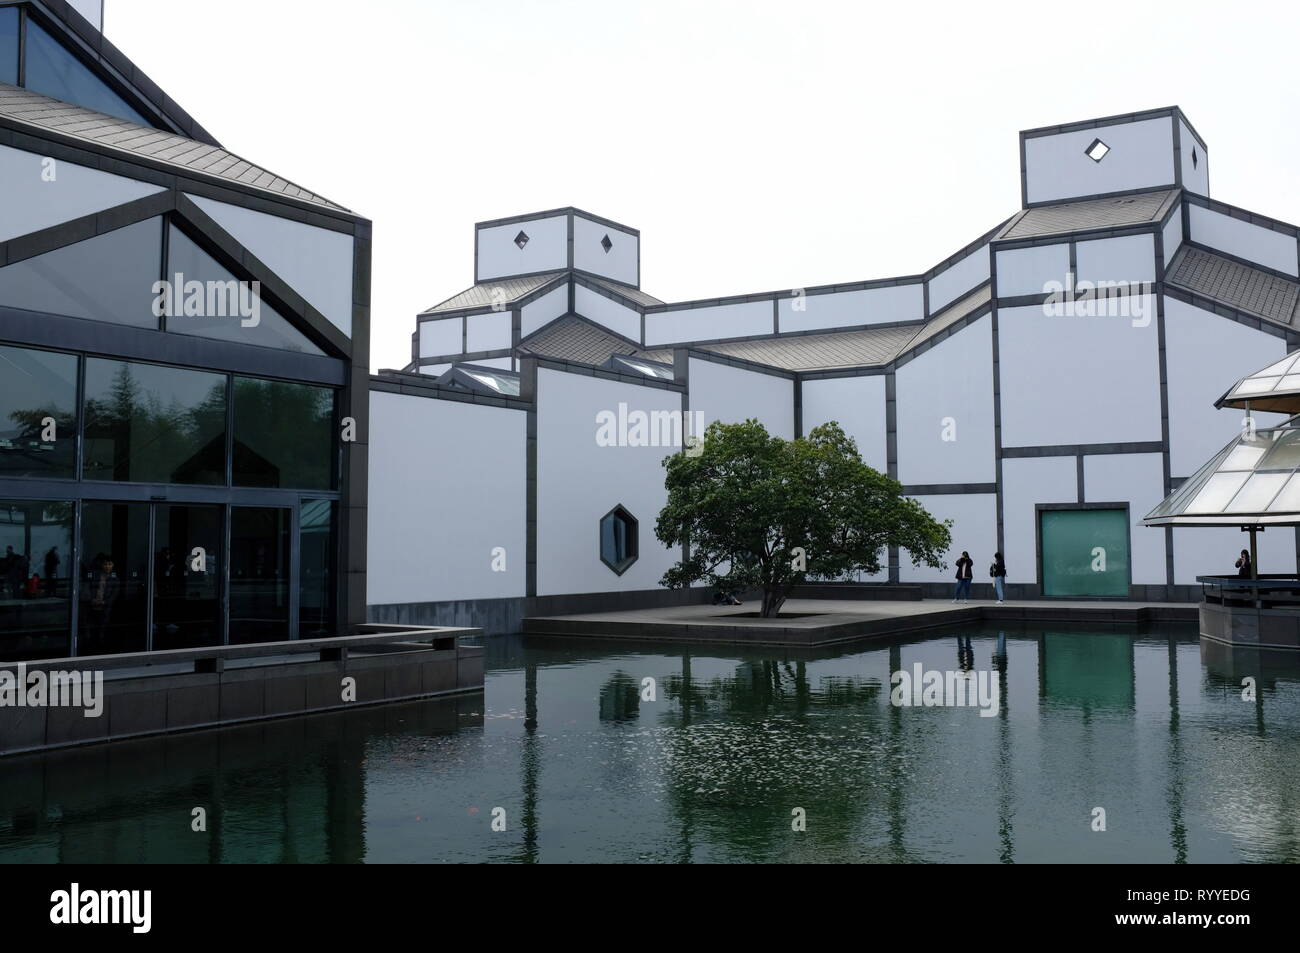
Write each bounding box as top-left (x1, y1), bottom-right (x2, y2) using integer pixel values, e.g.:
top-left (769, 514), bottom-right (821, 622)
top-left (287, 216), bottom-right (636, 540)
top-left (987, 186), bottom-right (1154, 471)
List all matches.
top-left (894, 316), bottom-right (996, 485)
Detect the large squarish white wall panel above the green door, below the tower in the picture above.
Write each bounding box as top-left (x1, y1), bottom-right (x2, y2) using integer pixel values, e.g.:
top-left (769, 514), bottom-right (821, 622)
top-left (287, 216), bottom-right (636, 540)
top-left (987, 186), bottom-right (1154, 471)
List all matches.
top-left (998, 295), bottom-right (1162, 447)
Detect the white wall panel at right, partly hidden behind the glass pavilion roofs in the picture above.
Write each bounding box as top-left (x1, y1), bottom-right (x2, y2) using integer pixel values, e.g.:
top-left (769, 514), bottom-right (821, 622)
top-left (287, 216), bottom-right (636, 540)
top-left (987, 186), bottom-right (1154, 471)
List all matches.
top-left (1165, 298), bottom-right (1286, 477)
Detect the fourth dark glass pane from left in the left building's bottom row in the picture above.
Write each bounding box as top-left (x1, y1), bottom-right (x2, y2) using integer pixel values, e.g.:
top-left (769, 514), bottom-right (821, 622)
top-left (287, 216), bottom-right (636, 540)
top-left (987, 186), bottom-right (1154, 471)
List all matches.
top-left (230, 506), bottom-right (290, 645)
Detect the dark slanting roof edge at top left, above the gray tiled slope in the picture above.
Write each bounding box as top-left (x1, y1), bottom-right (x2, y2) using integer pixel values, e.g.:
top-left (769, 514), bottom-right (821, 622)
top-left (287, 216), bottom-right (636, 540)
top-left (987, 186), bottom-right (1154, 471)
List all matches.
top-left (0, 0), bottom-right (221, 147)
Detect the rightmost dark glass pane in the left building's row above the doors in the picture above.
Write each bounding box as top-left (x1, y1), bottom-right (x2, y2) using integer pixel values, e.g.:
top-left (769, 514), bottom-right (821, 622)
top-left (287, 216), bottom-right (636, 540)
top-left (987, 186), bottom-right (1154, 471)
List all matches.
top-left (233, 377), bottom-right (335, 490)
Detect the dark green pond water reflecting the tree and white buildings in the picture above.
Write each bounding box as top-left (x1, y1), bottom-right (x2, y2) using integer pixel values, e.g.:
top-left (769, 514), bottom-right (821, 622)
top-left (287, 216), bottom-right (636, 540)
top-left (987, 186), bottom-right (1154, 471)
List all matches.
top-left (0, 628), bottom-right (1300, 863)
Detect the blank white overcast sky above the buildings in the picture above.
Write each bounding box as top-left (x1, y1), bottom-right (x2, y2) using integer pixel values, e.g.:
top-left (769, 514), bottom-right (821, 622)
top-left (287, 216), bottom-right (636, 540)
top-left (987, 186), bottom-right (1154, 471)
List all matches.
top-left (105, 0), bottom-right (1300, 368)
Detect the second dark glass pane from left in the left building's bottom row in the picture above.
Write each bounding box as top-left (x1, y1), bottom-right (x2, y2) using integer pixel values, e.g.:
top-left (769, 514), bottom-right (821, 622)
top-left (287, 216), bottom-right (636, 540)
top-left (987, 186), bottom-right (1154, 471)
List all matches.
top-left (77, 502), bottom-right (150, 655)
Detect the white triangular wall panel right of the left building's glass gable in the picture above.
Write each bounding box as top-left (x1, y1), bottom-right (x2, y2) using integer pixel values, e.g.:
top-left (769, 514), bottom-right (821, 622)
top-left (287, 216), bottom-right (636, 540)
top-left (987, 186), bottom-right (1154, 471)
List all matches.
top-left (190, 195), bottom-right (354, 337)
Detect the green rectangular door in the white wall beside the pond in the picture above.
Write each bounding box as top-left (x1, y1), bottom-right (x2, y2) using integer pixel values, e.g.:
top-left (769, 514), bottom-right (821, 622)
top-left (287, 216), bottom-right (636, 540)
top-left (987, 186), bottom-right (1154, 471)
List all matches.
top-left (1039, 510), bottom-right (1128, 598)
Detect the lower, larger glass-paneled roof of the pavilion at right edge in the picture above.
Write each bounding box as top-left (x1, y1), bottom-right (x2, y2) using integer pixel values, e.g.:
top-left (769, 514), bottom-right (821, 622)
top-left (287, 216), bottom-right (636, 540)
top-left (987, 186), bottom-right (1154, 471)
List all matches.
top-left (1143, 418), bottom-right (1300, 527)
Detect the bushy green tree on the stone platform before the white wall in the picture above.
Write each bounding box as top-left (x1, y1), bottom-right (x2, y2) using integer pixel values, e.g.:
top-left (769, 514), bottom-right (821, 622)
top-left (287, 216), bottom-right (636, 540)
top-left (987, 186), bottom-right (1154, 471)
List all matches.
top-left (655, 420), bottom-right (952, 618)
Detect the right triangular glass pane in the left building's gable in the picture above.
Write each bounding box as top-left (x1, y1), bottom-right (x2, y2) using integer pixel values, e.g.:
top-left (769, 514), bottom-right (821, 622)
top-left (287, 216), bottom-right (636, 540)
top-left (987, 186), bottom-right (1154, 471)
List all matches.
top-left (166, 225), bottom-right (325, 354)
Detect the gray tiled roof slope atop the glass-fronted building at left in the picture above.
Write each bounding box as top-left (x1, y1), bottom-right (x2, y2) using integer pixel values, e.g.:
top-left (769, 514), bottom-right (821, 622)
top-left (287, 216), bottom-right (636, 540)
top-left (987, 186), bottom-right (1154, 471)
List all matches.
top-left (0, 83), bottom-right (348, 212)
